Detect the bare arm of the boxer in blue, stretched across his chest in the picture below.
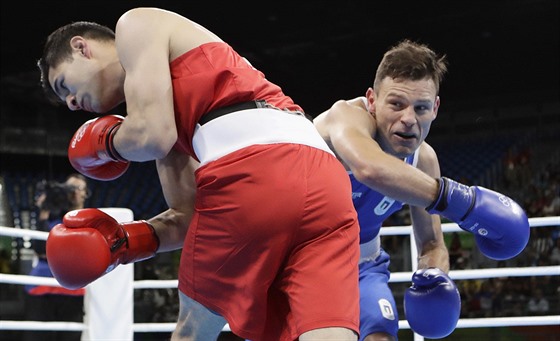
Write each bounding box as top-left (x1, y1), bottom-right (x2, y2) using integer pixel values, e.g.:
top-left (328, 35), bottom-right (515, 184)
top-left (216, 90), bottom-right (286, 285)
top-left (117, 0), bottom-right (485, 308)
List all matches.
top-left (314, 99), bottom-right (439, 208)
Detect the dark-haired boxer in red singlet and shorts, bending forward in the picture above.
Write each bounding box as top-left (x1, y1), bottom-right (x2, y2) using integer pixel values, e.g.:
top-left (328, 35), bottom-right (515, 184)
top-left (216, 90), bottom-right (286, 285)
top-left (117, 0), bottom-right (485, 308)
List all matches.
top-left (38, 8), bottom-right (359, 340)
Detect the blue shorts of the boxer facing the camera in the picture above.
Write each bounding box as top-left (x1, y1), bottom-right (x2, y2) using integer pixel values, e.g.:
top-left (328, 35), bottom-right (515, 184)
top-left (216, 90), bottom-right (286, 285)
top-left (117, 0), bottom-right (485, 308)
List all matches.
top-left (359, 249), bottom-right (399, 341)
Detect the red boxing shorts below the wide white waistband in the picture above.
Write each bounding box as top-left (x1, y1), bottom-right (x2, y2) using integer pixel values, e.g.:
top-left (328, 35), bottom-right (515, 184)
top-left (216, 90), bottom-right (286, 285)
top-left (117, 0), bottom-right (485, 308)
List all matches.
top-left (179, 144), bottom-right (359, 340)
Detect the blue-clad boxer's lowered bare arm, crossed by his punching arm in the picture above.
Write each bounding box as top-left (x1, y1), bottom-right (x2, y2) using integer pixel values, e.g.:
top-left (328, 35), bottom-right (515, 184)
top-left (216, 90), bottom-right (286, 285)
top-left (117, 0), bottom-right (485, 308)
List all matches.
top-left (410, 142), bottom-right (449, 273)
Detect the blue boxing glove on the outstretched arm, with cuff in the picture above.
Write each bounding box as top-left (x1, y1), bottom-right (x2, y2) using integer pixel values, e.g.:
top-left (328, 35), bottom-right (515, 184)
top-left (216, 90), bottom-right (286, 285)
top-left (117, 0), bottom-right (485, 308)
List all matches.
top-left (426, 177), bottom-right (530, 260)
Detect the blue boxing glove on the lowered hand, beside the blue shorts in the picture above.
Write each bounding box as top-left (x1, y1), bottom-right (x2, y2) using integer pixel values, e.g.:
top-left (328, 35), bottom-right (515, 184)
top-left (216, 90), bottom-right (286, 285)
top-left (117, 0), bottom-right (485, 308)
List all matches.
top-left (404, 268), bottom-right (461, 339)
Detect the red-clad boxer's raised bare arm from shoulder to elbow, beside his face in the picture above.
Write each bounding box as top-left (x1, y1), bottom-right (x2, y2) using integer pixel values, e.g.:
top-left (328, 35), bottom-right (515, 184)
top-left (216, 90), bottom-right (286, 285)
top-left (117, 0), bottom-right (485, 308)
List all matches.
top-left (110, 10), bottom-right (177, 161)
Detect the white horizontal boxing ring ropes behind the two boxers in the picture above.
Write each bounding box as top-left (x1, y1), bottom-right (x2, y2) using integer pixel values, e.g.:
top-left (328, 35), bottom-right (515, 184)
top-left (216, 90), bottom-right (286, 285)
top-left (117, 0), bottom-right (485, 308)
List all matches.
top-left (0, 217), bottom-right (560, 340)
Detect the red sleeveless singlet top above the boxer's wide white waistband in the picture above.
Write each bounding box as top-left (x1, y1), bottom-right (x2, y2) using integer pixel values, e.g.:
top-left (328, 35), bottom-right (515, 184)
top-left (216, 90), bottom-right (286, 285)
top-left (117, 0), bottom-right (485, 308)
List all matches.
top-left (170, 42), bottom-right (303, 158)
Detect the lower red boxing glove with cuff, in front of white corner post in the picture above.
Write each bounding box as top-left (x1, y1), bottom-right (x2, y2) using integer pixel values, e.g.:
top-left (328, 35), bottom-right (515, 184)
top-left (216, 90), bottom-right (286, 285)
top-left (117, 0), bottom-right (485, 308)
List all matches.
top-left (47, 208), bottom-right (159, 289)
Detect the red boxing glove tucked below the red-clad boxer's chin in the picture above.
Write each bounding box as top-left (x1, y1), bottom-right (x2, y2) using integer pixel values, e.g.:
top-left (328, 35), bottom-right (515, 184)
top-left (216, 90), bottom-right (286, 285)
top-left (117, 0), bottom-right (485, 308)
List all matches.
top-left (68, 115), bottom-right (130, 181)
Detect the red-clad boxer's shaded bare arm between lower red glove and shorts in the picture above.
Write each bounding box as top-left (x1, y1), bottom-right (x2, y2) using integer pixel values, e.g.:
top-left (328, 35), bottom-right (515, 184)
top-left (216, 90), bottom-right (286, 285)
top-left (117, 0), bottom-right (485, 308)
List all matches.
top-left (149, 150), bottom-right (198, 252)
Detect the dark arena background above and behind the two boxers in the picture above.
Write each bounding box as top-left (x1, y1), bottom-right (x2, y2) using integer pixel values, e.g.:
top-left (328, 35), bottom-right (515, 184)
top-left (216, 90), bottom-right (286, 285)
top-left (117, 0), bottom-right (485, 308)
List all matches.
top-left (0, 0), bottom-right (560, 340)
